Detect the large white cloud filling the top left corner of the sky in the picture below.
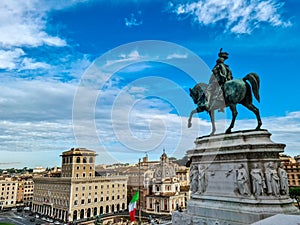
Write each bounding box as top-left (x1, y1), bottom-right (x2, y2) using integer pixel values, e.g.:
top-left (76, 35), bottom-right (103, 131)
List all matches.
top-left (0, 0), bottom-right (66, 47)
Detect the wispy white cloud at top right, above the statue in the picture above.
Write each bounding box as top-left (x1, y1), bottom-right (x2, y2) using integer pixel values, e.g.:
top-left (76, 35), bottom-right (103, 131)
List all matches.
top-left (171, 0), bottom-right (291, 34)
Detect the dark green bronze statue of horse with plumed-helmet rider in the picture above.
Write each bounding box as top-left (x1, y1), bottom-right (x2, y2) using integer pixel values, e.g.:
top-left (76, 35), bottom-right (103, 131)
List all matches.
top-left (188, 49), bottom-right (262, 135)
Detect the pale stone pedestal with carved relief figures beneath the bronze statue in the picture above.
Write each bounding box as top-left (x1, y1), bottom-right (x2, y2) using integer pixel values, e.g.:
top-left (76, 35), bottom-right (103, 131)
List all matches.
top-left (172, 130), bottom-right (299, 225)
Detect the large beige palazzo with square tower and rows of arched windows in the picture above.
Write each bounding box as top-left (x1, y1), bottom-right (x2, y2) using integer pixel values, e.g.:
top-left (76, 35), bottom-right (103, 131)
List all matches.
top-left (32, 148), bottom-right (127, 221)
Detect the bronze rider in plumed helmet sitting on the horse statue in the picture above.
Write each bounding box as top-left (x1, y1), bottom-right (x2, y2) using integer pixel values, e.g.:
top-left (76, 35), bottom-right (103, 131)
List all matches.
top-left (206, 48), bottom-right (233, 112)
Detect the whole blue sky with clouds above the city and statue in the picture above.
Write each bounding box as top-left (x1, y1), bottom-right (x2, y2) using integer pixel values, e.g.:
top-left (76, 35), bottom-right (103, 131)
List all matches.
top-left (0, 0), bottom-right (300, 168)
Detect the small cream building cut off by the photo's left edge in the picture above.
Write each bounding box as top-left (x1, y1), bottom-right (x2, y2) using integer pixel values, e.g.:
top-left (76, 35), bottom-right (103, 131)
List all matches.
top-left (0, 178), bottom-right (18, 209)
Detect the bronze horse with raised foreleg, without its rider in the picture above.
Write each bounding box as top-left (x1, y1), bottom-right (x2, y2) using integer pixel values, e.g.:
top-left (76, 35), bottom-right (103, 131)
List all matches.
top-left (188, 73), bottom-right (262, 135)
